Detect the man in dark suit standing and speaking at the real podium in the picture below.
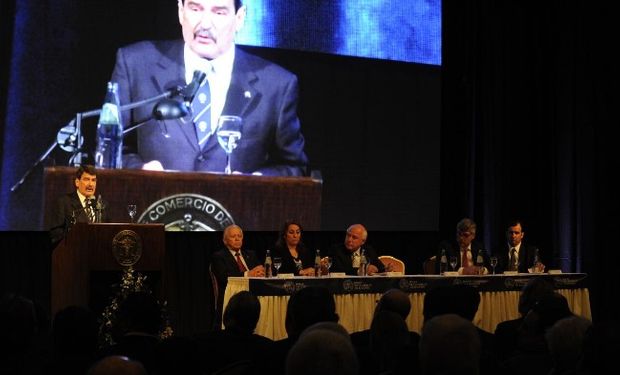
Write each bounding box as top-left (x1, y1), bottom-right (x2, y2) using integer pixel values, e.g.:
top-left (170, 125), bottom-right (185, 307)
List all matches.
top-left (49, 165), bottom-right (108, 243)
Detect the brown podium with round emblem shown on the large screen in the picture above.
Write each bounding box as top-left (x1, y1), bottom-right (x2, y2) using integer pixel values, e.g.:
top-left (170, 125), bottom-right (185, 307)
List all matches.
top-left (44, 167), bottom-right (323, 231)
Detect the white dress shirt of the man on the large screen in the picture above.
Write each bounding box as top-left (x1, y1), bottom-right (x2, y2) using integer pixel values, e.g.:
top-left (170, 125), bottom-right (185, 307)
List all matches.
top-left (183, 44), bottom-right (235, 133)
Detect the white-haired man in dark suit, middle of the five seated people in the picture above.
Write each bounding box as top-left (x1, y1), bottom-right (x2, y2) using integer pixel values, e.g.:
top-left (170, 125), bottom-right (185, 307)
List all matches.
top-left (329, 224), bottom-right (385, 276)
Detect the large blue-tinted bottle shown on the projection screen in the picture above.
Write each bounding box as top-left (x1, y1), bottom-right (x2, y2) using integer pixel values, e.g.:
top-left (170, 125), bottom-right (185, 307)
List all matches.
top-left (95, 81), bottom-right (123, 168)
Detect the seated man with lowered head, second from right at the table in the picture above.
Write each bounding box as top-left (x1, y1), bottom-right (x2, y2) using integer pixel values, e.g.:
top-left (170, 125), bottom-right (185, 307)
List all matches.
top-left (435, 217), bottom-right (489, 275)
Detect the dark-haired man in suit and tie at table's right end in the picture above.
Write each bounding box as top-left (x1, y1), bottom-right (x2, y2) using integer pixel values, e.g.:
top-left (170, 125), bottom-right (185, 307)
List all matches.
top-left (495, 220), bottom-right (545, 273)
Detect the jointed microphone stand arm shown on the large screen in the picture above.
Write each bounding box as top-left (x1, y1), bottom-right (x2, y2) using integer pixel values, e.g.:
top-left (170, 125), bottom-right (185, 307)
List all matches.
top-left (11, 86), bottom-right (183, 193)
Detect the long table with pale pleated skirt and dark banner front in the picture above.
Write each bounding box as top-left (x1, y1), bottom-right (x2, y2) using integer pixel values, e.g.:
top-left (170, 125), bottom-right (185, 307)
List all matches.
top-left (224, 273), bottom-right (592, 340)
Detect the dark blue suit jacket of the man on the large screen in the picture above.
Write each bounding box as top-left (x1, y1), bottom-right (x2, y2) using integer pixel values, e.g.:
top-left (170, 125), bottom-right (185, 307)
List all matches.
top-left (112, 40), bottom-right (308, 176)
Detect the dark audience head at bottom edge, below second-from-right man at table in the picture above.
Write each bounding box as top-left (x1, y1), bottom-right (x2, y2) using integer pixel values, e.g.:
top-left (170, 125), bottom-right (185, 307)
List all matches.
top-left (420, 314), bottom-right (481, 375)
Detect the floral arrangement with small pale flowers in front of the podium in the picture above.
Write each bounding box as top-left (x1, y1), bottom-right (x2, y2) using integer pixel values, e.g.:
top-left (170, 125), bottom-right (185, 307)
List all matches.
top-left (99, 267), bottom-right (174, 347)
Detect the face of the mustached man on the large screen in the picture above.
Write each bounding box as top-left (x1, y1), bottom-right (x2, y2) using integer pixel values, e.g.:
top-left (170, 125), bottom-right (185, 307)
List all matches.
top-left (178, 0), bottom-right (245, 60)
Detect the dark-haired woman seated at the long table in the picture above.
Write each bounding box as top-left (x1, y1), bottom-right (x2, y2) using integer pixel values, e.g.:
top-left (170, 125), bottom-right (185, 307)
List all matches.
top-left (274, 220), bottom-right (314, 276)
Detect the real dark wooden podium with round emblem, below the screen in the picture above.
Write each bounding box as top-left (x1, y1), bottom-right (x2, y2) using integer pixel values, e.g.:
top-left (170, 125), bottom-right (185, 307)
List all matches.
top-left (51, 223), bottom-right (165, 314)
